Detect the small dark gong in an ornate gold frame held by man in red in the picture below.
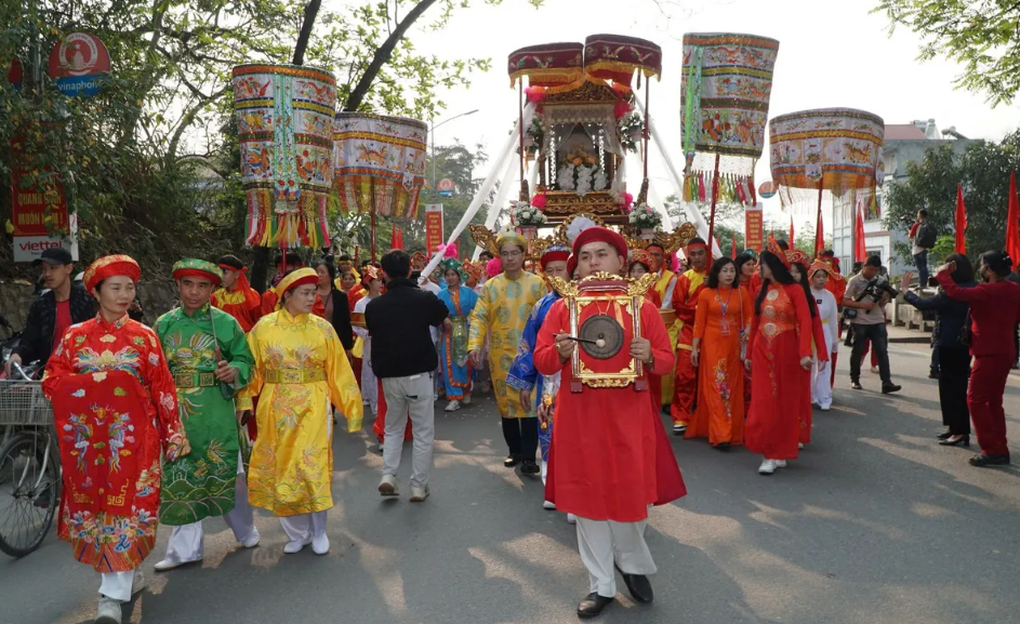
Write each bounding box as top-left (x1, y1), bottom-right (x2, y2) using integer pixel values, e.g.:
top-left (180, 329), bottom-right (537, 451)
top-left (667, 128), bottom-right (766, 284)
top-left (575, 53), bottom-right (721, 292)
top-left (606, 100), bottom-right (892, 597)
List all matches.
top-left (551, 272), bottom-right (656, 394)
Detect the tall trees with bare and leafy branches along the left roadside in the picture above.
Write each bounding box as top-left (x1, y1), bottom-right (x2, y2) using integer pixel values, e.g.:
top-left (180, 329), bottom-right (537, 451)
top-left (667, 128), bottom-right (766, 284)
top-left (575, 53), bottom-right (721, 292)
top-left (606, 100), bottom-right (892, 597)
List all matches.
top-left (0, 0), bottom-right (541, 279)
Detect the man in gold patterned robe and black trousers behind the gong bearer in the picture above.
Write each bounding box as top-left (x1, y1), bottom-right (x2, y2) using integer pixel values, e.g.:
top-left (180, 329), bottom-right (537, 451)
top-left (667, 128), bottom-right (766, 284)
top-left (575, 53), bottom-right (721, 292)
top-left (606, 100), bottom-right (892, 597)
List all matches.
top-left (467, 231), bottom-right (547, 474)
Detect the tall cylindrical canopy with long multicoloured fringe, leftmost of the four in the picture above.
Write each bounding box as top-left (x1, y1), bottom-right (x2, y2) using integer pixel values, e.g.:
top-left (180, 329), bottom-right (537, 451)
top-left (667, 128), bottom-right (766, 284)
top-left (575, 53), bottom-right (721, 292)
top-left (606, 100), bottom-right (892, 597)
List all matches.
top-left (233, 65), bottom-right (337, 247)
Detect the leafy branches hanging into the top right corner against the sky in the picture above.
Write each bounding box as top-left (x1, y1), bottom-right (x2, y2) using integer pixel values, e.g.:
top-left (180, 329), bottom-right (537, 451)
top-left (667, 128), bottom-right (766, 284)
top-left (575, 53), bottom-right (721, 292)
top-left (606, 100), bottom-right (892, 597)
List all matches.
top-left (873, 0), bottom-right (1020, 105)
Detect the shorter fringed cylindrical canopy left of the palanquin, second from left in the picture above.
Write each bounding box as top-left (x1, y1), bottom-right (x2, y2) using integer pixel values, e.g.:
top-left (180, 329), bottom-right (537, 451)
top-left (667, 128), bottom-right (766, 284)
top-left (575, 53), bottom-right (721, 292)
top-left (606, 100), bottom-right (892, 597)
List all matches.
top-left (334, 112), bottom-right (428, 218)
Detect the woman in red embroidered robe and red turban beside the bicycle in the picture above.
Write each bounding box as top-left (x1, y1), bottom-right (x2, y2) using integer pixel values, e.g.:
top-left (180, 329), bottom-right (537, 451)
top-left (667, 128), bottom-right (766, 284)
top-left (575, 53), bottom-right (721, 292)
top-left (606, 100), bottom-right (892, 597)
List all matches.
top-left (43, 256), bottom-right (190, 623)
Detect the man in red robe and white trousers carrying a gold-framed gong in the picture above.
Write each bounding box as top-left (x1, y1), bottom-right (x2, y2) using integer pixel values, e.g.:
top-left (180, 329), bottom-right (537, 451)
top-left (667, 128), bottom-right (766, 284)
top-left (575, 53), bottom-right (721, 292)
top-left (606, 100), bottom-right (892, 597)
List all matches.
top-left (534, 227), bottom-right (686, 618)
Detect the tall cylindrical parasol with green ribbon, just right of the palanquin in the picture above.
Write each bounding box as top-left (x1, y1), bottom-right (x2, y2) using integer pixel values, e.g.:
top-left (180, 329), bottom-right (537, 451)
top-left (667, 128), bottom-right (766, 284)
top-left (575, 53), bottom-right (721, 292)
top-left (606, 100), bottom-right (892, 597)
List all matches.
top-left (680, 33), bottom-right (779, 253)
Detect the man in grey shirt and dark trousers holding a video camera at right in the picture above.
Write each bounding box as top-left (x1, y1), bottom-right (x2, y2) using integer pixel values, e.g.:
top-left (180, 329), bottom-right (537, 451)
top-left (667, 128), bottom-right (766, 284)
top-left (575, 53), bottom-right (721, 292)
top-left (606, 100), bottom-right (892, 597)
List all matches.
top-left (843, 256), bottom-right (901, 395)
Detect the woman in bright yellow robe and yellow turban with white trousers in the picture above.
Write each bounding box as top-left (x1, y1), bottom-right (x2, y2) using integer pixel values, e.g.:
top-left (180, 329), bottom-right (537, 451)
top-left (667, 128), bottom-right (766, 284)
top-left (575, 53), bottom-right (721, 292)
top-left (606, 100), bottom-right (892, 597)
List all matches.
top-left (238, 268), bottom-right (362, 555)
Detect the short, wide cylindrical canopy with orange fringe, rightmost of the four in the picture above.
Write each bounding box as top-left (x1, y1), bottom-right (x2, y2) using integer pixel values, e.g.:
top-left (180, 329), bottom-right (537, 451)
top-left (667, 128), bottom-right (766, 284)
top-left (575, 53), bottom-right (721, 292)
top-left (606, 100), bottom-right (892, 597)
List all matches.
top-left (769, 108), bottom-right (885, 206)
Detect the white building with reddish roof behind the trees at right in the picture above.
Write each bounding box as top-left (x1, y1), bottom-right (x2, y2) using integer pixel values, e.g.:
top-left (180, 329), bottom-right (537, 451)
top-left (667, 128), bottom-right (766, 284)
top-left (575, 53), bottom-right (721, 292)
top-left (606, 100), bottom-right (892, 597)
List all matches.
top-left (832, 119), bottom-right (973, 274)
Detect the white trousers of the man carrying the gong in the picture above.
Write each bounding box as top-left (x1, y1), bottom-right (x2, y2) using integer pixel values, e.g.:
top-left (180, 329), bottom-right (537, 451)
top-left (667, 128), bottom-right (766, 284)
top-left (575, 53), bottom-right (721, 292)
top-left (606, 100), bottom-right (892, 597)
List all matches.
top-left (577, 516), bottom-right (658, 597)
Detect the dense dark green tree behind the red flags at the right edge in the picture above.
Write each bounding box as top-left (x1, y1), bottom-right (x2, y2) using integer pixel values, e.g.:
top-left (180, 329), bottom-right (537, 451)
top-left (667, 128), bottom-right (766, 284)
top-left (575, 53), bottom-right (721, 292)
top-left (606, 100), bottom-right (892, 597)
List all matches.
top-left (885, 132), bottom-right (1020, 263)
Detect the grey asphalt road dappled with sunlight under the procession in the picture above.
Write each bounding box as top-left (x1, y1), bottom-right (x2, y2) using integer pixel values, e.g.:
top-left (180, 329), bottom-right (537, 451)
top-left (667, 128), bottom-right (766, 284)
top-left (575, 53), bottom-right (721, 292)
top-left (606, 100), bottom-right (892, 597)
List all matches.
top-left (0, 345), bottom-right (1020, 624)
